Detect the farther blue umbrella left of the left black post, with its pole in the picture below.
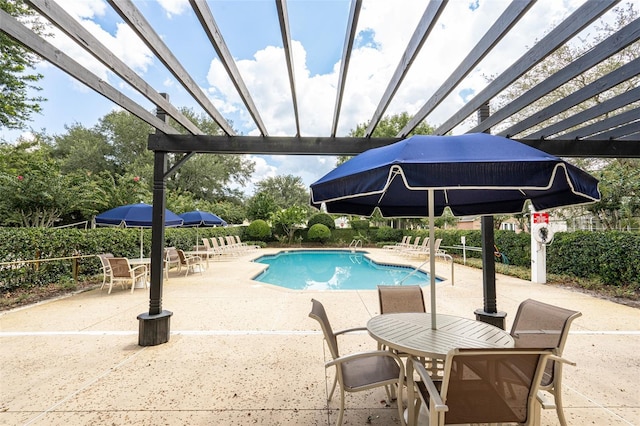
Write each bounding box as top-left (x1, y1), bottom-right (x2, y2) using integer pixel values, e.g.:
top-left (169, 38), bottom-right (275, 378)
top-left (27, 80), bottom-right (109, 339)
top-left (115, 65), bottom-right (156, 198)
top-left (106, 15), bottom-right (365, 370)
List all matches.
top-left (95, 203), bottom-right (183, 258)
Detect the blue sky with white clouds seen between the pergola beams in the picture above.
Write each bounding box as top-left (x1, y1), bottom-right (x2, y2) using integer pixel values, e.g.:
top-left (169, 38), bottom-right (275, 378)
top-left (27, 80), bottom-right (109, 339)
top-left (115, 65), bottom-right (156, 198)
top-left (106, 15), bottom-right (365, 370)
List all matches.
top-left (0, 0), bottom-right (600, 195)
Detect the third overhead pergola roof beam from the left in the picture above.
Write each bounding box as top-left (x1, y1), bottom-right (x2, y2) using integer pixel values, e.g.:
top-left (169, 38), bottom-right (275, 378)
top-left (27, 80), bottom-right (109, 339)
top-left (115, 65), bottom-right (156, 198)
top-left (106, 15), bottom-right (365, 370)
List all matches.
top-left (107, 0), bottom-right (235, 135)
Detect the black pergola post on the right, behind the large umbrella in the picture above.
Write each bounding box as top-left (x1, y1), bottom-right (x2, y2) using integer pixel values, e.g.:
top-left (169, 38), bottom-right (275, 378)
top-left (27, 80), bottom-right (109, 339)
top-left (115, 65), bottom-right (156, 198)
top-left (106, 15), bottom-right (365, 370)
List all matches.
top-left (474, 104), bottom-right (507, 330)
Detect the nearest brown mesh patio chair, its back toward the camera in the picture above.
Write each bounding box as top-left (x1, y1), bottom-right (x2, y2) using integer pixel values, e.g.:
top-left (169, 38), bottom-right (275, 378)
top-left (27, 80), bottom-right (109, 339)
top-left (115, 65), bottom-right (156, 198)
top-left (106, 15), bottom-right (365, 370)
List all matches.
top-left (407, 348), bottom-right (553, 426)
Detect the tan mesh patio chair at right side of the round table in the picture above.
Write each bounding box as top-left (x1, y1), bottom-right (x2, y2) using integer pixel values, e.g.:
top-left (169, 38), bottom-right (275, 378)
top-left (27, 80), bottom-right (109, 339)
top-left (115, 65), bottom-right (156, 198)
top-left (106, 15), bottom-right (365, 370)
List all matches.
top-left (511, 299), bottom-right (582, 426)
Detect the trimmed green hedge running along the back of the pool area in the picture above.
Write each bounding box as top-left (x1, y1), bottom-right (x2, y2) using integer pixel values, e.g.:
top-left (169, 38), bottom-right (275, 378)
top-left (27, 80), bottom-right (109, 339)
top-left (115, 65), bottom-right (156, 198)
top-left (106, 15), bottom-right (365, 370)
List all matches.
top-left (0, 227), bottom-right (640, 293)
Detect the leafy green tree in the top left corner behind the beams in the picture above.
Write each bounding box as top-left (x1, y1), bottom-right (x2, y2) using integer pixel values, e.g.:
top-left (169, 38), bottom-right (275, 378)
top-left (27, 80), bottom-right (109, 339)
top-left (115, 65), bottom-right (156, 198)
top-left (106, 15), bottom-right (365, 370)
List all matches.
top-left (0, 0), bottom-right (45, 129)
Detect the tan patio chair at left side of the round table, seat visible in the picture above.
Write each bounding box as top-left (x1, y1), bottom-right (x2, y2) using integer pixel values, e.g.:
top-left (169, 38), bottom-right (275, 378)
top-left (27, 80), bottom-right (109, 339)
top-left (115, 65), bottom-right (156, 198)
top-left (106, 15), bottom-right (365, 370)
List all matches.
top-left (309, 299), bottom-right (404, 425)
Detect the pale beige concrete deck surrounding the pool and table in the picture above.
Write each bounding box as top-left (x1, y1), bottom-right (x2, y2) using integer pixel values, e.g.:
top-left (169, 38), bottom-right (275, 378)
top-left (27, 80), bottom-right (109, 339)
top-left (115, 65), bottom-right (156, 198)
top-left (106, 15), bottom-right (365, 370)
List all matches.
top-left (0, 249), bottom-right (640, 426)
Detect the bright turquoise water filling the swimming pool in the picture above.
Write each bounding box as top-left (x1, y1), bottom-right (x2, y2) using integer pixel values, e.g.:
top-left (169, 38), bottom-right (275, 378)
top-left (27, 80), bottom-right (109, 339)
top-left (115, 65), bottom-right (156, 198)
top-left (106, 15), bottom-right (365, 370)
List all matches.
top-left (254, 250), bottom-right (429, 290)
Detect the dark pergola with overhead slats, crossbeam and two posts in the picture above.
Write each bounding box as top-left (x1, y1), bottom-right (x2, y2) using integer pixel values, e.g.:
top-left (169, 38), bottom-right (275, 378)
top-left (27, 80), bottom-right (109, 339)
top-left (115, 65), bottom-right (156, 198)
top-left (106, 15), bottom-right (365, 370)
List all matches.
top-left (0, 0), bottom-right (640, 346)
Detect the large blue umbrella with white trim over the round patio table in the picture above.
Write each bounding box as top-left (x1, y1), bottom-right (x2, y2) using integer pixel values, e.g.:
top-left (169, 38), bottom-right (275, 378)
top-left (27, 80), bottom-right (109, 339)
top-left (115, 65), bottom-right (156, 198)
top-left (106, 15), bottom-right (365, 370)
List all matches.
top-left (311, 133), bottom-right (600, 328)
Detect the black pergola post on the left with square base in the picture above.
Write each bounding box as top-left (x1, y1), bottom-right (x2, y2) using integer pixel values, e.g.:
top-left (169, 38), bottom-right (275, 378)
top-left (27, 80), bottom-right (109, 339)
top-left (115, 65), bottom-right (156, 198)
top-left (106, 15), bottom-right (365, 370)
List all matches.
top-left (138, 94), bottom-right (173, 346)
